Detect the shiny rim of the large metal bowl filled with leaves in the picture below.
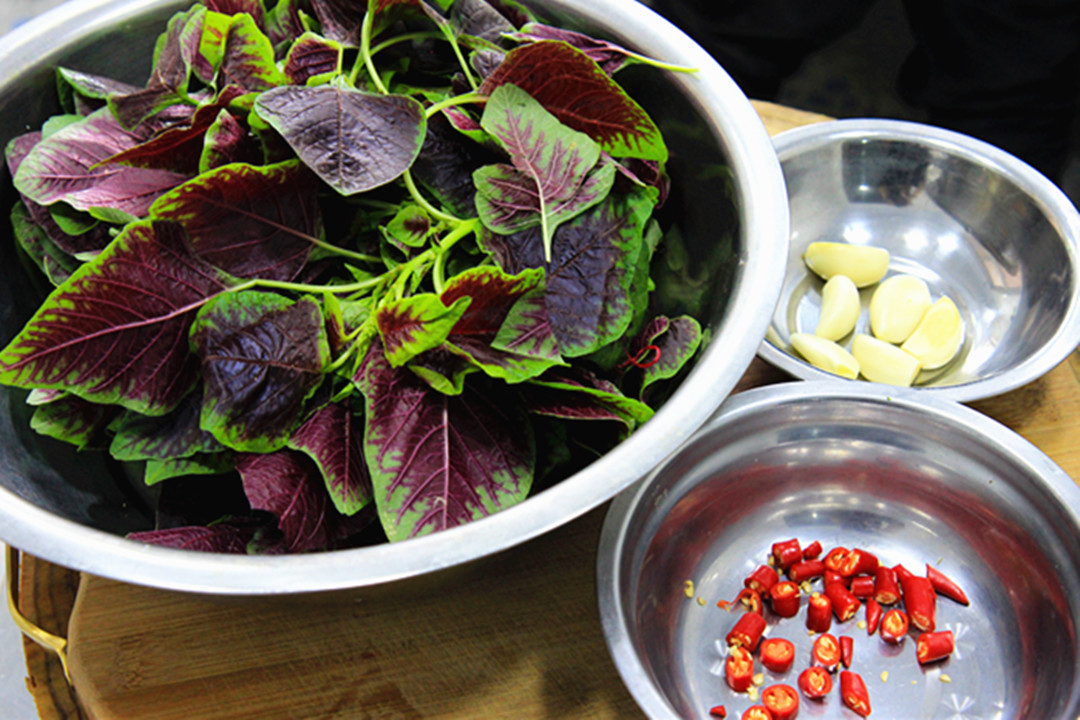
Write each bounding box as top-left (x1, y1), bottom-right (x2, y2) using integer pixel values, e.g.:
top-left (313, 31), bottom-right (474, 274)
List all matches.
top-left (0, 0), bottom-right (789, 595)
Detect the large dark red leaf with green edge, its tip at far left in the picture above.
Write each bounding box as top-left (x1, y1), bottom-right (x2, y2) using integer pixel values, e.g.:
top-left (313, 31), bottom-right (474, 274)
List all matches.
top-left (0, 222), bottom-right (234, 415)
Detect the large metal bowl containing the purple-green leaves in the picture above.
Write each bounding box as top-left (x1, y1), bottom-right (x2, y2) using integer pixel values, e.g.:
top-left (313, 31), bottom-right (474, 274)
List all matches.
top-left (0, 0), bottom-right (788, 594)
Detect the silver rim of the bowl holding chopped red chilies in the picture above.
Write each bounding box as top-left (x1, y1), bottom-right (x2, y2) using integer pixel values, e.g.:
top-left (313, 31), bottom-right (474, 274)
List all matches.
top-left (596, 379), bottom-right (1080, 720)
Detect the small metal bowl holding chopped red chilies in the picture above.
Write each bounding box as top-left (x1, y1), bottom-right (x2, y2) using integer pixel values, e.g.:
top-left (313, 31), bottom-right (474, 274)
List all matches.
top-left (597, 381), bottom-right (1080, 720)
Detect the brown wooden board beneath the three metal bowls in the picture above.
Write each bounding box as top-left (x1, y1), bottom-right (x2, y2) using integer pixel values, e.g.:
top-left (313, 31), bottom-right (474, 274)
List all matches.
top-left (19, 104), bottom-right (1080, 720)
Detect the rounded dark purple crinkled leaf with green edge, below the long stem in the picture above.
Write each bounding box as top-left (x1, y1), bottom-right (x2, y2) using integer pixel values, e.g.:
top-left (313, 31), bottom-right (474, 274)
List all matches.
top-left (191, 291), bottom-right (329, 452)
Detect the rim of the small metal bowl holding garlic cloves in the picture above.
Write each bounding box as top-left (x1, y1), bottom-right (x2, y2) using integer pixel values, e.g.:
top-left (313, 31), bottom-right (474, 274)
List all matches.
top-left (757, 118), bottom-right (1080, 403)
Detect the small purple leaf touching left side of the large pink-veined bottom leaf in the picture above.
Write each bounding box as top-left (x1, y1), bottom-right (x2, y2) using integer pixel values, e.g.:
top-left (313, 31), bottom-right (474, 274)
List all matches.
top-left (288, 403), bottom-right (372, 515)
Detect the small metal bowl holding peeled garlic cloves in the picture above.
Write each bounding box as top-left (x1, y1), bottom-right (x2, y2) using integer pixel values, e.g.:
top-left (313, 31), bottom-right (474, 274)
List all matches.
top-left (758, 120), bottom-right (1080, 402)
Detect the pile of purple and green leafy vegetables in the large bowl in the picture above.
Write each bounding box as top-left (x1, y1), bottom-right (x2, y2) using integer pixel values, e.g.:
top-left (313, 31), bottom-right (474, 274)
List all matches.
top-left (0, 0), bottom-right (702, 553)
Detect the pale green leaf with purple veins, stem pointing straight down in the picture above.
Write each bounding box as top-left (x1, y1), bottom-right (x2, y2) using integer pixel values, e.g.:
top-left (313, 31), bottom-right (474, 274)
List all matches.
top-left (473, 85), bottom-right (615, 260)
